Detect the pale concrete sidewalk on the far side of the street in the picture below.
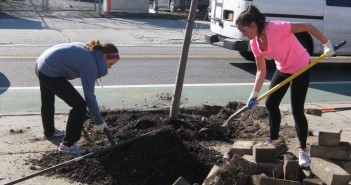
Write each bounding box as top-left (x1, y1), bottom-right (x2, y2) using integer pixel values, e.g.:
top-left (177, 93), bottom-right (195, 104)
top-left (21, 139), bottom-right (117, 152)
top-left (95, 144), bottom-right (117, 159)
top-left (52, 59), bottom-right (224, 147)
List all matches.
top-left (0, 10), bottom-right (209, 46)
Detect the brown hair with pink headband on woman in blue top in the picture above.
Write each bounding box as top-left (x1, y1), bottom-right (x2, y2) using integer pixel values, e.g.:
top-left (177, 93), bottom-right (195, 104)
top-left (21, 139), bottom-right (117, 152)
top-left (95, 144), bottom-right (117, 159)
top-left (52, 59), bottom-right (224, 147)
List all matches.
top-left (86, 40), bottom-right (119, 60)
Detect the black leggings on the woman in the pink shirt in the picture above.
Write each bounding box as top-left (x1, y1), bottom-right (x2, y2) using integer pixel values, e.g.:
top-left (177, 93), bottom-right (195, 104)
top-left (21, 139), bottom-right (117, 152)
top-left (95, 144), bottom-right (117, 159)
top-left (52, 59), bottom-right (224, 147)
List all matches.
top-left (266, 70), bottom-right (310, 148)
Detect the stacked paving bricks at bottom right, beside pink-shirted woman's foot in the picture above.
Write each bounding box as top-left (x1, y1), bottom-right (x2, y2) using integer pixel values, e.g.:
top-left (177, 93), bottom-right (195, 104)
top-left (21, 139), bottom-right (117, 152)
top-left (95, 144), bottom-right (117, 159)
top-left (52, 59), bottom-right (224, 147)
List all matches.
top-left (306, 130), bottom-right (351, 185)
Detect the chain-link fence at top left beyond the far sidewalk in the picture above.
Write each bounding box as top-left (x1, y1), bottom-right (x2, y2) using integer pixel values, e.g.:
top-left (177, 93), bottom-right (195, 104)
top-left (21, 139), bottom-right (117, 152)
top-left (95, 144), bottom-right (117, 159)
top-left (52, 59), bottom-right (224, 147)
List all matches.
top-left (0, 0), bottom-right (99, 11)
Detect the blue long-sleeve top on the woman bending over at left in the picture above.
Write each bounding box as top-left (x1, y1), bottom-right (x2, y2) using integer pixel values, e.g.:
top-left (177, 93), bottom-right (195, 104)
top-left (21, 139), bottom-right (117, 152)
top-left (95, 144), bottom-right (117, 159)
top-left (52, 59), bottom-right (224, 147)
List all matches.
top-left (37, 42), bottom-right (107, 125)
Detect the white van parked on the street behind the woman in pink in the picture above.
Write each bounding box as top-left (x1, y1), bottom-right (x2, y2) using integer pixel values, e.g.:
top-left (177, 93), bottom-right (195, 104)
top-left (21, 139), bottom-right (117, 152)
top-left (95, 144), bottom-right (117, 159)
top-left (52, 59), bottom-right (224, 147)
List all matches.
top-left (205, 0), bottom-right (351, 60)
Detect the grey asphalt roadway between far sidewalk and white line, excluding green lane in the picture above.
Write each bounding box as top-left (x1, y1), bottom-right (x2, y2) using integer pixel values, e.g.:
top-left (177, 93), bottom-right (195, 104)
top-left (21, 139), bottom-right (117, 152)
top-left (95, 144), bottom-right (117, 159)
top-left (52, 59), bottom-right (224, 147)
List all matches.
top-left (0, 44), bottom-right (351, 87)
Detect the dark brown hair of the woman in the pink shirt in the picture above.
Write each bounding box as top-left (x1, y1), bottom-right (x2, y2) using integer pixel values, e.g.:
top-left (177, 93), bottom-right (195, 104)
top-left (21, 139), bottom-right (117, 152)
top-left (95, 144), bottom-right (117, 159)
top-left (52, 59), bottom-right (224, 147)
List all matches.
top-left (235, 5), bottom-right (266, 35)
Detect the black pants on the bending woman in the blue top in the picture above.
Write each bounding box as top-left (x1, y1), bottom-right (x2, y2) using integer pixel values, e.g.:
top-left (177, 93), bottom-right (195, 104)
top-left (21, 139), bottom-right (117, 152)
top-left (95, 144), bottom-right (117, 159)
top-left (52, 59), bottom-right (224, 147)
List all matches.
top-left (38, 72), bottom-right (87, 146)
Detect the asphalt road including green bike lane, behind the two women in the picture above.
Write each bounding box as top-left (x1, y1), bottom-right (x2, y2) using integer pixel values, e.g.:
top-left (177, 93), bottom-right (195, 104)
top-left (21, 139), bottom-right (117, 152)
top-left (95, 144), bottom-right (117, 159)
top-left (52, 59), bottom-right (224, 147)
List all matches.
top-left (0, 44), bottom-right (351, 114)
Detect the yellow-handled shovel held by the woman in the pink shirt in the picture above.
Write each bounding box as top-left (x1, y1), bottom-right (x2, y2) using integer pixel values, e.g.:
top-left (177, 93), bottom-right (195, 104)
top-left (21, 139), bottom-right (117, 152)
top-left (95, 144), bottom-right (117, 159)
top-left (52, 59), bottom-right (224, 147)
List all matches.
top-left (199, 41), bottom-right (346, 133)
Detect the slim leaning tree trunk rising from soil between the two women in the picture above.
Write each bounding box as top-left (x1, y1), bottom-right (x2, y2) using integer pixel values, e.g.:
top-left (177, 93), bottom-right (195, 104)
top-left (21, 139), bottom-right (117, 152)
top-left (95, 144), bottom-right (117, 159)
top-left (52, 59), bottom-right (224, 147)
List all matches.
top-left (169, 0), bottom-right (198, 119)
